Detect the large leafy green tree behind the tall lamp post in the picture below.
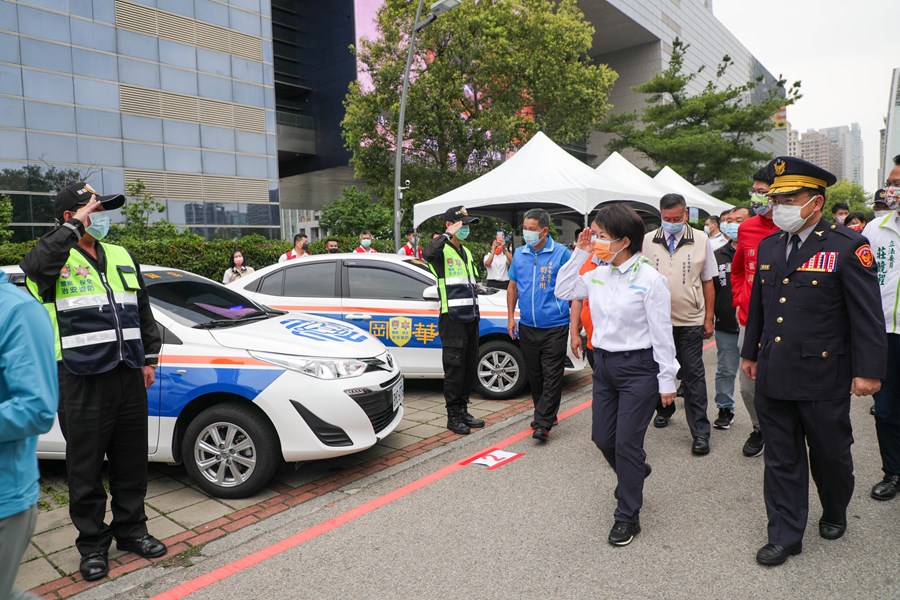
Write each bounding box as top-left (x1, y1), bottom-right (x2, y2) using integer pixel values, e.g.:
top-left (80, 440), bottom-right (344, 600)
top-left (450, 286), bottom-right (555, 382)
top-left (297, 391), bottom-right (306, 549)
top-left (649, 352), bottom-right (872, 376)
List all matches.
top-left (343, 0), bottom-right (616, 223)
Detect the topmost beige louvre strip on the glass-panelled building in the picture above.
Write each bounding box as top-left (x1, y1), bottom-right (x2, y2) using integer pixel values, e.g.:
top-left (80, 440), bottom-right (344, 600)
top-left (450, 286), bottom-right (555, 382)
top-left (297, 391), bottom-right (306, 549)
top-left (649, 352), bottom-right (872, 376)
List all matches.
top-left (116, 0), bottom-right (262, 61)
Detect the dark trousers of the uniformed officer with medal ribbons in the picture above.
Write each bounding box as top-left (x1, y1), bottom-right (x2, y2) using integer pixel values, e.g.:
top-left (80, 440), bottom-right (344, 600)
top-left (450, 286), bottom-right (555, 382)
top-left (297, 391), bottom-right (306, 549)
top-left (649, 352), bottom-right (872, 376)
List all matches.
top-left (755, 388), bottom-right (854, 547)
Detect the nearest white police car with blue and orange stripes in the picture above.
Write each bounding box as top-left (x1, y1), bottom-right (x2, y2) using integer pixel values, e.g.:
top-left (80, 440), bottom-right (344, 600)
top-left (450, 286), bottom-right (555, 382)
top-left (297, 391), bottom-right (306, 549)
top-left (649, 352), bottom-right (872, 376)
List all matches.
top-left (3, 267), bottom-right (403, 498)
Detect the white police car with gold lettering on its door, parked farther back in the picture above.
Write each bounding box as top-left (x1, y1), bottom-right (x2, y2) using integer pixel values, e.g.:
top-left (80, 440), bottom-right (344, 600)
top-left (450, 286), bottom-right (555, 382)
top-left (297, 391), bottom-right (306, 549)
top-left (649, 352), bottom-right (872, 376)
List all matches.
top-left (231, 253), bottom-right (586, 400)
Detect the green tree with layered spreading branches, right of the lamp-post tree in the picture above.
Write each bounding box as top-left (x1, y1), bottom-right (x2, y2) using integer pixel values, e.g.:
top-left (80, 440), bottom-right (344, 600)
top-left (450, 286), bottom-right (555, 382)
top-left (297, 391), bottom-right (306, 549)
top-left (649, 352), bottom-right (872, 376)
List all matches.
top-left (601, 38), bottom-right (801, 200)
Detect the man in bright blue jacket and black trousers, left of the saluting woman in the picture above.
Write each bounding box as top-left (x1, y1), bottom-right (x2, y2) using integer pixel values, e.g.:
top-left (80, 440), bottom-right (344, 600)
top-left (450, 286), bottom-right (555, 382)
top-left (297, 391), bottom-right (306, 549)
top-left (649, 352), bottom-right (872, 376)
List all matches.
top-left (506, 208), bottom-right (572, 442)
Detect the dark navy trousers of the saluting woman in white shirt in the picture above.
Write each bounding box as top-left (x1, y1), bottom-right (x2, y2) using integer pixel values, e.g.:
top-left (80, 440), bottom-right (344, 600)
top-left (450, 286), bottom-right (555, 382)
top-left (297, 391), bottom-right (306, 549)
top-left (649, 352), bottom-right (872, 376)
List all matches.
top-left (591, 348), bottom-right (659, 523)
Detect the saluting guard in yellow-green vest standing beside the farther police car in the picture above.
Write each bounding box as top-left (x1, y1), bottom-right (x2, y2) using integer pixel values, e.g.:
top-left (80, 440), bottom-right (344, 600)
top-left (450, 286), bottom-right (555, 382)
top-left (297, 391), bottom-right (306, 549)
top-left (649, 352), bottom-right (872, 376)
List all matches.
top-left (423, 206), bottom-right (484, 435)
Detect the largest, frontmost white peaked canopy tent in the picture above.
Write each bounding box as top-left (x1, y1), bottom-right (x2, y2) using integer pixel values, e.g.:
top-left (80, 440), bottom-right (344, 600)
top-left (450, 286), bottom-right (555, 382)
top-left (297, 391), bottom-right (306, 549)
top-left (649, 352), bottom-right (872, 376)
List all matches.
top-left (413, 132), bottom-right (659, 227)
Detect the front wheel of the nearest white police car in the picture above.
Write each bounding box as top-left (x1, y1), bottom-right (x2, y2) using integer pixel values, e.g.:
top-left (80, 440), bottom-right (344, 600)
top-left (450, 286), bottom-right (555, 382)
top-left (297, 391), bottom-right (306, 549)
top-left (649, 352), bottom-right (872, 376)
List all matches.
top-left (181, 404), bottom-right (281, 498)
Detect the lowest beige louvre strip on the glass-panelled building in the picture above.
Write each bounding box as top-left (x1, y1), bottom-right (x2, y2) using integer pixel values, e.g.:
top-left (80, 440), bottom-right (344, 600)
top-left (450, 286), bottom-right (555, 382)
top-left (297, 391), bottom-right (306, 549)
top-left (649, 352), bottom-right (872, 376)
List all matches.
top-left (125, 169), bottom-right (269, 203)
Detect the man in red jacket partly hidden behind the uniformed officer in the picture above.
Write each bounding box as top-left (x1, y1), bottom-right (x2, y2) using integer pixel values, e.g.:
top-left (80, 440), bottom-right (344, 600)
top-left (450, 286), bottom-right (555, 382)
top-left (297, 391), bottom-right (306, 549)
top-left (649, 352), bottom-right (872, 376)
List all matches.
top-left (731, 169), bottom-right (778, 457)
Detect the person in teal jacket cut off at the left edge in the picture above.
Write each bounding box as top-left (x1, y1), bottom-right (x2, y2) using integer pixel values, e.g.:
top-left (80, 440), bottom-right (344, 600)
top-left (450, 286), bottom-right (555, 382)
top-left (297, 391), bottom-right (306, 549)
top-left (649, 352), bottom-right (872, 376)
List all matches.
top-left (0, 271), bottom-right (59, 598)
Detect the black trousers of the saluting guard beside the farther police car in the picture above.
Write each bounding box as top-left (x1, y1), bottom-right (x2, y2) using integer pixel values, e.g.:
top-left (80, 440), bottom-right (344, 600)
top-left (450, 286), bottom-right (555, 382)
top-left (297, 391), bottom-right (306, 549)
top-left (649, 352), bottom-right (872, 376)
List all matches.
top-left (438, 314), bottom-right (479, 411)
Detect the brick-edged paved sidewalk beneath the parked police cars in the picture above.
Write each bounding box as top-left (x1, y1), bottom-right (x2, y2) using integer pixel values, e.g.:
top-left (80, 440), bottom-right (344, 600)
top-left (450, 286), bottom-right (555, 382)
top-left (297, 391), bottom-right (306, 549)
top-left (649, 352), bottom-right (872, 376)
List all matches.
top-left (16, 370), bottom-right (590, 598)
